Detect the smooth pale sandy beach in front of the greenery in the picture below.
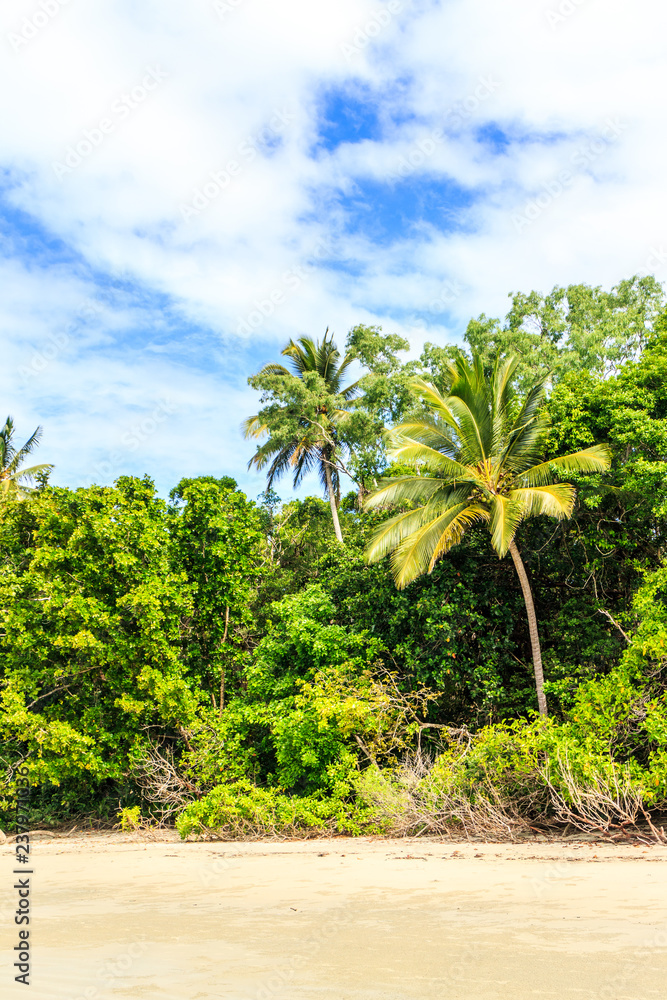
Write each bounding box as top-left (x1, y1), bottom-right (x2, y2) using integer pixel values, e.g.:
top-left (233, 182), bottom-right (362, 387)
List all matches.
top-left (0, 834), bottom-right (667, 1000)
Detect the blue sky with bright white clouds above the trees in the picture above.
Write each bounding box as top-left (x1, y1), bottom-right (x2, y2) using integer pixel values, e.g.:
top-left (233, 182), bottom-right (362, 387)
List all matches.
top-left (0, 0), bottom-right (667, 499)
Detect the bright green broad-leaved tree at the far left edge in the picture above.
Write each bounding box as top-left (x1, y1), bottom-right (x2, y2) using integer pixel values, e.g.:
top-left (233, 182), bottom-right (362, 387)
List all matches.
top-left (0, 479), bottom-right (200, 820)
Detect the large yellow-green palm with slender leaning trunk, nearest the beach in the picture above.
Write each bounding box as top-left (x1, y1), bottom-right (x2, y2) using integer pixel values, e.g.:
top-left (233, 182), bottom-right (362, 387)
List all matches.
top-left (366, 356), bottom-right (610, 715)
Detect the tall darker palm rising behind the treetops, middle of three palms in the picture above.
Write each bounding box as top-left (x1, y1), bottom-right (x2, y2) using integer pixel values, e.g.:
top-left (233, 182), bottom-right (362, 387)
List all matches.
top-left (243, 328), bottom-right (359, 544)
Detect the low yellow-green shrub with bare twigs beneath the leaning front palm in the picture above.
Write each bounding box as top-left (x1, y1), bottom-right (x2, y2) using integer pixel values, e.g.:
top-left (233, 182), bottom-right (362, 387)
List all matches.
top-left (357, 721), bottom-right (667, 842)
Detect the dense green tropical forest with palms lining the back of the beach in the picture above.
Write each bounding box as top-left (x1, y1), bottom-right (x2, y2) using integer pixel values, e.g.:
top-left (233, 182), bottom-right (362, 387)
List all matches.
top-left (0, 278), bottom-right (667, 836)
